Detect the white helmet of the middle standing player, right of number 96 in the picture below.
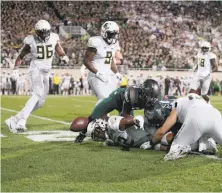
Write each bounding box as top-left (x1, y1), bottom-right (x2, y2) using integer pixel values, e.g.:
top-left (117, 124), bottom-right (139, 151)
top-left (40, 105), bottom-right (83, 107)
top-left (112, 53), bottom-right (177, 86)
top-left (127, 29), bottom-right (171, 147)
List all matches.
top-left (101, 21), bottom-right (119, 44)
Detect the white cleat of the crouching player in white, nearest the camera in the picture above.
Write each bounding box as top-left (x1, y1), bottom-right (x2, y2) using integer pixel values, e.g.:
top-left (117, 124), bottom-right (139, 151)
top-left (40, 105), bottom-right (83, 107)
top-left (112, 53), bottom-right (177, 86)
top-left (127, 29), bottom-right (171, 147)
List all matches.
top-left (164, 145), bottom-right (191, 161)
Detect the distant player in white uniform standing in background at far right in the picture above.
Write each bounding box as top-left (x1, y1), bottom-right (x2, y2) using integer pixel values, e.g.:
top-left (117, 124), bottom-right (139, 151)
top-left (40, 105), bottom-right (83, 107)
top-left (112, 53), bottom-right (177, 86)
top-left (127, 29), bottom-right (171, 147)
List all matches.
top-left (190, 41), bottom-right (218, 102)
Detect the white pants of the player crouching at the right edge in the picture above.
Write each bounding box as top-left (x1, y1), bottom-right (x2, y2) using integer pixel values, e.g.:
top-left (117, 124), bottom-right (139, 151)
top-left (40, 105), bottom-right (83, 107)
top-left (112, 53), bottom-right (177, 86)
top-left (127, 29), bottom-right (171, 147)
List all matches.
top-left (172, 106), bottom-right (222, 146)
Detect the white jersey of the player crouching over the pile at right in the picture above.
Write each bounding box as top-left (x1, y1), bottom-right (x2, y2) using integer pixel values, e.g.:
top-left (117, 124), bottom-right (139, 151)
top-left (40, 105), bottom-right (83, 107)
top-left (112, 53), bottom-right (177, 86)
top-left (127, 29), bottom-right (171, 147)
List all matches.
top-left (172, 93), bottom-right (210, 123)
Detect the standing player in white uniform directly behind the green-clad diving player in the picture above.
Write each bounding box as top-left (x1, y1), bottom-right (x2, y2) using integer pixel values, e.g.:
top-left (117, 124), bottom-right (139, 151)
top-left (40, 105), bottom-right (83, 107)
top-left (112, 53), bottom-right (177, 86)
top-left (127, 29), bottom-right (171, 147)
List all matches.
top-left (84, 21), bottom-right (122, 103)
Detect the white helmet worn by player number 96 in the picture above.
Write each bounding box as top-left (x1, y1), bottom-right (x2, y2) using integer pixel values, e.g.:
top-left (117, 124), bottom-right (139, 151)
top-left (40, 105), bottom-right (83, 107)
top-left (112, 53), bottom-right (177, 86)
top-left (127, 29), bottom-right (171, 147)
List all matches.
top-left (35, 19), bottom-right (51, 42)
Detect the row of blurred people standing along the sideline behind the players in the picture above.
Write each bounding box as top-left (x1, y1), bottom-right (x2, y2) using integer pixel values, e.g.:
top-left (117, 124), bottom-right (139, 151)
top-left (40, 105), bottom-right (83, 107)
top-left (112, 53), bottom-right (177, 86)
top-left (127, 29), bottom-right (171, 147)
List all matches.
top-left (0, 68), bottom-right (222, 96)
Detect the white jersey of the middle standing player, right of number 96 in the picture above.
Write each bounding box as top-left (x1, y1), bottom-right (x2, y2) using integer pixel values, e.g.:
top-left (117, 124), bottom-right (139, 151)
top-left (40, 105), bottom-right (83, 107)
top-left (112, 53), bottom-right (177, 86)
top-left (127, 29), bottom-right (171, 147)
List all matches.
top-left (87, 36), bottom-right (120, 74)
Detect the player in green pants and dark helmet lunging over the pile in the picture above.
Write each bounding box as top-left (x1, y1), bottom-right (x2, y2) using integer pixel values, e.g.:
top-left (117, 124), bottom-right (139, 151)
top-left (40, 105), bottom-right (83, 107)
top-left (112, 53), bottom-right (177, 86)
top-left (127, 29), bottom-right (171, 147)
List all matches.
top-left (75, 79), bottom-right (159, 143)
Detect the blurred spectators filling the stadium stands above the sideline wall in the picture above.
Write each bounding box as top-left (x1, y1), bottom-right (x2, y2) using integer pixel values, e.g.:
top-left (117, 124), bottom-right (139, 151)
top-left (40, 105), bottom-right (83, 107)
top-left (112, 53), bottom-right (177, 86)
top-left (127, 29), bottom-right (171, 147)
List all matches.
top-left (1, 1), bottom-right (222, 70)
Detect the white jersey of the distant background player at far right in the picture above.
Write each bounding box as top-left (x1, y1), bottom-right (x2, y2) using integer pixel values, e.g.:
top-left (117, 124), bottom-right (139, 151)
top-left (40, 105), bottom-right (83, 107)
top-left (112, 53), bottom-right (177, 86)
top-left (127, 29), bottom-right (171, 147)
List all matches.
top-left (197, 52), bottom-right (216, 77)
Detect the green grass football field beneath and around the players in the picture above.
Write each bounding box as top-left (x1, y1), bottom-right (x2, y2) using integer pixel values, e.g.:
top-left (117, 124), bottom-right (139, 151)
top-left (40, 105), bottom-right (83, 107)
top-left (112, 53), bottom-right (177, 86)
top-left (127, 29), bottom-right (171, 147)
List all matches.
top-left (1, 96), bottom-right (222, 192)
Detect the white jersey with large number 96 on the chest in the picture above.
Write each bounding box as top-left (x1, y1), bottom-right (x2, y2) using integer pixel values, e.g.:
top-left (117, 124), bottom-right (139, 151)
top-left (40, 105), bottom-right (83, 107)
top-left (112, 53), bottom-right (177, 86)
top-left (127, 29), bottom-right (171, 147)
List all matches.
top-left (24, 33), bottom-right (59, 70)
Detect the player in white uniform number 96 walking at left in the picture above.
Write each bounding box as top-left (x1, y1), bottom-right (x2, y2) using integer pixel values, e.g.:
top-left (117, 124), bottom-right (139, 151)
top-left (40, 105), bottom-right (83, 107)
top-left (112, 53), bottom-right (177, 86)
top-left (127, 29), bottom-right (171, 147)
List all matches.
top-left (5, 20), bottom-right (69, 133)
